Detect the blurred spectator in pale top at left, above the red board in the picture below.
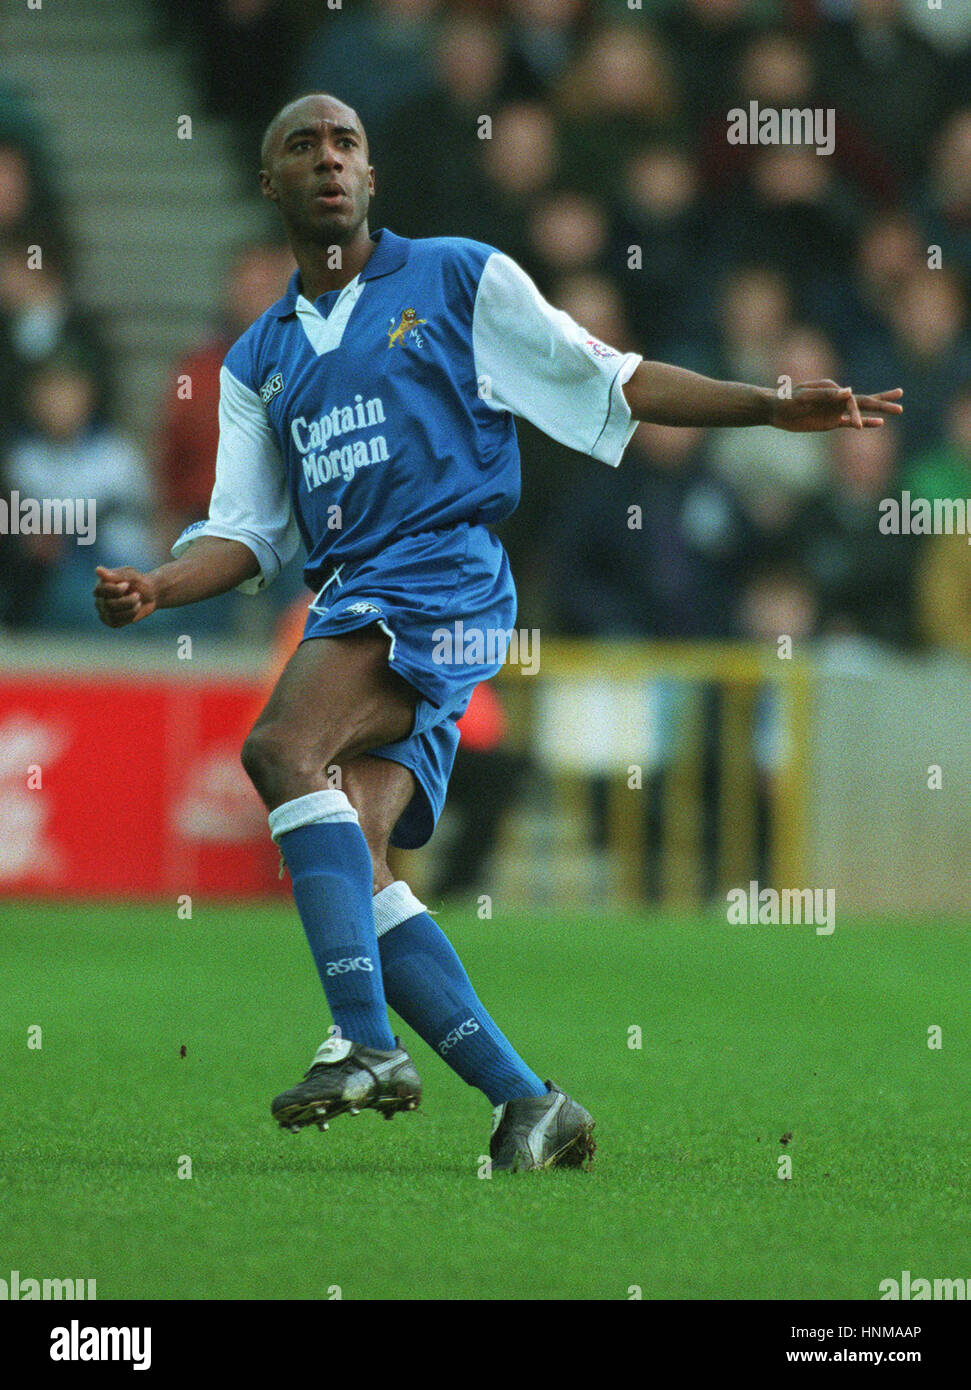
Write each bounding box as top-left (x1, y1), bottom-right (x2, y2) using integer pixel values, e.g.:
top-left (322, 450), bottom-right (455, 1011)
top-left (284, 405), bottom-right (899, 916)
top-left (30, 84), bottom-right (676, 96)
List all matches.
top-left (3, 356), bottom-right (161, 631)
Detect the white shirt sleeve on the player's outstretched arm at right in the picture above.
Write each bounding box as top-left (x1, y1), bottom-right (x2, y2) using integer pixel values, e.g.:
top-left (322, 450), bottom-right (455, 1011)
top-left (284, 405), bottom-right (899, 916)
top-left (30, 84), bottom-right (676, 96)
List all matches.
top-left (472, 252), bottom-right (642, 468)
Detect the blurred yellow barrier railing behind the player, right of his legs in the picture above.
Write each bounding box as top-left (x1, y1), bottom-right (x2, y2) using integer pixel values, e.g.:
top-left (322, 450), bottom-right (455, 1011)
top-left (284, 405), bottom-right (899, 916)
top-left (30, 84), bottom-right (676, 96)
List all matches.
top-left (499, 639), bottom-right (811, 906)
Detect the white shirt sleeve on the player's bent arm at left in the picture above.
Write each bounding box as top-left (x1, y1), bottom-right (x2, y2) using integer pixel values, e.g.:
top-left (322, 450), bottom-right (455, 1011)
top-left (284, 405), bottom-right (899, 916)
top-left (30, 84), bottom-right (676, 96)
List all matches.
top-left (172, 367), bottom-right (300, 594)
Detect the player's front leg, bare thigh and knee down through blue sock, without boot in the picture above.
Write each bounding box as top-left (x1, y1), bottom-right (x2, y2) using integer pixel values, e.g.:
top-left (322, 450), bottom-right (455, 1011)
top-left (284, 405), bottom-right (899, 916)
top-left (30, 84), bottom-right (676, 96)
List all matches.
top-left (243, 627), bottom-right (417, 1051)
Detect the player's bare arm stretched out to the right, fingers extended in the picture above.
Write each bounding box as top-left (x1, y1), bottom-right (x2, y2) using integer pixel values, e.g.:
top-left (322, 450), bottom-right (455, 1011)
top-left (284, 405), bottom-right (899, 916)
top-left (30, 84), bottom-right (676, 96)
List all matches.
top-left (624, 361), bottom-right (903, 432)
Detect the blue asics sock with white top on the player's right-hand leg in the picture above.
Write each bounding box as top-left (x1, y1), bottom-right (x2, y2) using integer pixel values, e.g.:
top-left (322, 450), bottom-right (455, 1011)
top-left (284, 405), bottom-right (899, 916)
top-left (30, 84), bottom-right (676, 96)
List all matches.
top-left (374, 880), bottom-right (547, 1105)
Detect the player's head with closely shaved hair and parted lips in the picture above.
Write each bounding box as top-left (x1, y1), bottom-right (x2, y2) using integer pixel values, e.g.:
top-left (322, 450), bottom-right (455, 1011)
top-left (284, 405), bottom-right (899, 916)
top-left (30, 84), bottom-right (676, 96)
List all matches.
top-left (260, 99), bottom-right (374, 245)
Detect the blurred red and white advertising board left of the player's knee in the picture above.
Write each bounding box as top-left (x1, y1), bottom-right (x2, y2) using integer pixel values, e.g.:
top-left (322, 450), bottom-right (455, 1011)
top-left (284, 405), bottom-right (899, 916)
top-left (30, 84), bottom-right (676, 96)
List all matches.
top-left (0, 671), bottom-right (283, 898)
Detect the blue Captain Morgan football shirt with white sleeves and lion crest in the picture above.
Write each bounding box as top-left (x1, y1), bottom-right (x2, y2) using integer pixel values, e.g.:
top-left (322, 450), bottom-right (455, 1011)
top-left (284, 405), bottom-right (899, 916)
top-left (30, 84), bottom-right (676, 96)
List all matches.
top-left (172, 229), bottom-right (640, 592)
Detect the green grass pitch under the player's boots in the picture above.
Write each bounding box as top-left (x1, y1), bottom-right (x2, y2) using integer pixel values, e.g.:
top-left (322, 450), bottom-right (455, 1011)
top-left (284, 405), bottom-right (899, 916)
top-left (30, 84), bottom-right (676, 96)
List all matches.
top-left (0, 902), bottom-right (971, 1300)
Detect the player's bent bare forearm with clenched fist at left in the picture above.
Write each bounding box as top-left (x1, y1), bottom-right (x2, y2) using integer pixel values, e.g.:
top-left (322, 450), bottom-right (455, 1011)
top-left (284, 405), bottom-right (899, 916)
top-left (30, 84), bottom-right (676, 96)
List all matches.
top-left (94, 535), bottom-right (260, 627)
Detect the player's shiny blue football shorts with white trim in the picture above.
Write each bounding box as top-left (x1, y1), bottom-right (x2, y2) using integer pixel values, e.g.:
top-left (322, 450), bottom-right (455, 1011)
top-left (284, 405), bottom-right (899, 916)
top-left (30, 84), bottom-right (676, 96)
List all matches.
top-left (303, 523), bottom-right (515, 849)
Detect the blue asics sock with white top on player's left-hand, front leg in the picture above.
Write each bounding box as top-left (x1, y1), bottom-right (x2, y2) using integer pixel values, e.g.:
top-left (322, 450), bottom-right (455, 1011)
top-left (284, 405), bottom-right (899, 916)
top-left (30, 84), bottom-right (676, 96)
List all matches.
top-left (269, 791), bottom-right (395, 1051)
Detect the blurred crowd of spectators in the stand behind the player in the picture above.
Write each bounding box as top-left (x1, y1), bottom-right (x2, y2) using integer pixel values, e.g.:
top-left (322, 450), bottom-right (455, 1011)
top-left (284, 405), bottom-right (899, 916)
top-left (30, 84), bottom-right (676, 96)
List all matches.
top-left (0, 0), bottom-right (971, 655)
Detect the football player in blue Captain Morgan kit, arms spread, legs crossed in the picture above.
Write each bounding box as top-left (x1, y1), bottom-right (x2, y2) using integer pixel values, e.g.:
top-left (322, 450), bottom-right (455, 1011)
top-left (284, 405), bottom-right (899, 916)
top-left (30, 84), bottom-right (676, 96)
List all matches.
top-left (94, 93), bottom-right (902, 1170)
